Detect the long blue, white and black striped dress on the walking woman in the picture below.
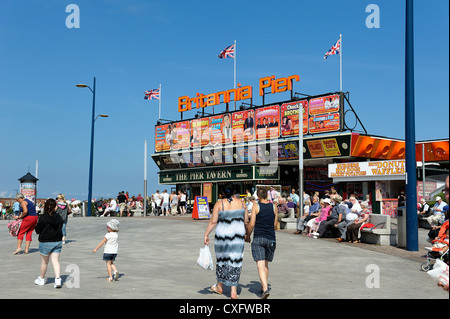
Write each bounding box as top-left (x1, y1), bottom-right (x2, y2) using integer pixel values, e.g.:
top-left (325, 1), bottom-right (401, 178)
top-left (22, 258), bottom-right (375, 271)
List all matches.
top-left (214, 209), bottom-right (245, 286)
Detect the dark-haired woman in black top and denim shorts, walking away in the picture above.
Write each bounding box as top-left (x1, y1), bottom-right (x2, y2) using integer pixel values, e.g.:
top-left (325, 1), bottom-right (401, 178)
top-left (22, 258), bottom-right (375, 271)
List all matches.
top-left (34, 198), bottom-right (63, 288)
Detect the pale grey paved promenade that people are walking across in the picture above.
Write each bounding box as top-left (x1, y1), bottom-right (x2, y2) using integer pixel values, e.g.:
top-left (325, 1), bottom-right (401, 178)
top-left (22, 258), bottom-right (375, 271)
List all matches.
top-left (0, 216), bottom-right (448, 300)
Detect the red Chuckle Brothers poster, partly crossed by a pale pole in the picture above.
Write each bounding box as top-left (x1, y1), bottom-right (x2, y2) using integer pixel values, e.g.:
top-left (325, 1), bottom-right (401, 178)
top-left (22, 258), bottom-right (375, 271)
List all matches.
top-left (281, 100), bottom-right (308, 137)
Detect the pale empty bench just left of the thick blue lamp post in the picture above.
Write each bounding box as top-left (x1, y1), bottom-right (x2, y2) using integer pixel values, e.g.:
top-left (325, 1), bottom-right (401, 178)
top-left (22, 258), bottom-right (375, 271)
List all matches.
top-left (361, 214), bottom-right (397, 246)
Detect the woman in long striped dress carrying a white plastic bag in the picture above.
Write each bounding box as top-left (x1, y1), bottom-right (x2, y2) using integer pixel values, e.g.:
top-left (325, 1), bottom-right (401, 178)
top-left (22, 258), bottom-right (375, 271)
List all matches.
top-left (204, 185), bottom-right (248, 299)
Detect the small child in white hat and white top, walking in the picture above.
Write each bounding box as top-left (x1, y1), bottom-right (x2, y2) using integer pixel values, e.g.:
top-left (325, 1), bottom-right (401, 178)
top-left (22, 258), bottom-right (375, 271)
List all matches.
top-left (92, 219), bottom-right (119, 281)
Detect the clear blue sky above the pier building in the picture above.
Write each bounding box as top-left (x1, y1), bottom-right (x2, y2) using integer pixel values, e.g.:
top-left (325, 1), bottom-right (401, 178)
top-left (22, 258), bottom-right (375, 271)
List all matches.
top-left (0, 0), bottom-right (449, 199)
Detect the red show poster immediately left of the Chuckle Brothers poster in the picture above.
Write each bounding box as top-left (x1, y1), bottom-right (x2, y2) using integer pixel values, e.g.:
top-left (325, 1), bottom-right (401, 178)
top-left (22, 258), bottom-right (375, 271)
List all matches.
top-left (255, 105), bottom-right (280, 140)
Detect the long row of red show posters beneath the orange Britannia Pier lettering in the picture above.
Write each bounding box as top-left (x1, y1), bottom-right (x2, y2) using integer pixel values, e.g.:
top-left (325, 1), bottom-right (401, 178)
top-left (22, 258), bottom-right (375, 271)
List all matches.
top-left (155, 92), bottom-right (344, 153)
